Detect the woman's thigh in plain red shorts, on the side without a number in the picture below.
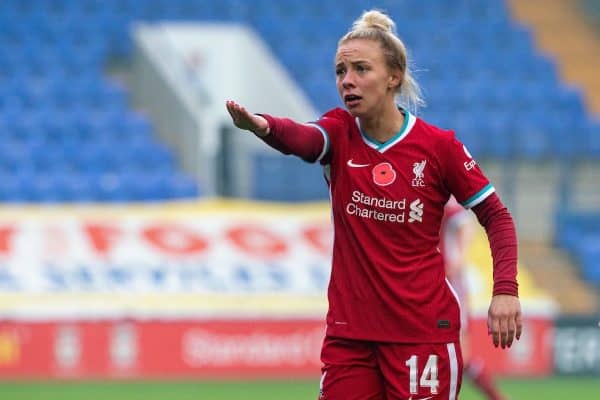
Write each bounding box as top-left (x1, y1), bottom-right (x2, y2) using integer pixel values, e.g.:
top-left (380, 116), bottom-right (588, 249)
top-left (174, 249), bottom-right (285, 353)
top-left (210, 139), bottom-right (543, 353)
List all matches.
top-left (319, 337), bottom-right (385, 400)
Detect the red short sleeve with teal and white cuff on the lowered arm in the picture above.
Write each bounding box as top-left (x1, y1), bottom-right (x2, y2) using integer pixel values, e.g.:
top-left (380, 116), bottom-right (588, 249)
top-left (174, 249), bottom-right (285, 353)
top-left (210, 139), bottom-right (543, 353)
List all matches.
top-left (441, 132), bottom-right (495, 208)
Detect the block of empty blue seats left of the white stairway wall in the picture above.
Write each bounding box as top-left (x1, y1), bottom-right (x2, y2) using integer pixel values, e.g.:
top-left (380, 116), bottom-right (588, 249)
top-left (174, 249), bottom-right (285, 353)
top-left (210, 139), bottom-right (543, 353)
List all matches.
top-left (0, 0), bottom-right (199, 203)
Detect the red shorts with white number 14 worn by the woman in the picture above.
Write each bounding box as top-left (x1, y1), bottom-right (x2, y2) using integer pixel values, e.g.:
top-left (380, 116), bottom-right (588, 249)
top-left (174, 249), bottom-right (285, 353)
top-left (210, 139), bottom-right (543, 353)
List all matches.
top-left (319, 337), bottom-right (463, 400)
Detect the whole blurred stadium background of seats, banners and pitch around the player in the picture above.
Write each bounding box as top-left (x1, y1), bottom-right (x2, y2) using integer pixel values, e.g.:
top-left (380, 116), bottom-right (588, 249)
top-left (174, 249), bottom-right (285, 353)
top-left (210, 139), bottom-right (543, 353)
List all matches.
top-left (0, 0), bottom-right (600, 400)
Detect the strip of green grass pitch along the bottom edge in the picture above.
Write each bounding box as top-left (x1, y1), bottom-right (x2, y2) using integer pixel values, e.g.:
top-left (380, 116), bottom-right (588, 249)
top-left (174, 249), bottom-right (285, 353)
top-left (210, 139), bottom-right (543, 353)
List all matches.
top-left (0, 377), bottom-right (600, 400)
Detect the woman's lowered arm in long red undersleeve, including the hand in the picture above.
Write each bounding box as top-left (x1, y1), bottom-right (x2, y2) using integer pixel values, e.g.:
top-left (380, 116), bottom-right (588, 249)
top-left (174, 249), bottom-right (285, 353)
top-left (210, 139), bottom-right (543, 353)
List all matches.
top-left (473, 194), bottom-right (523, 348)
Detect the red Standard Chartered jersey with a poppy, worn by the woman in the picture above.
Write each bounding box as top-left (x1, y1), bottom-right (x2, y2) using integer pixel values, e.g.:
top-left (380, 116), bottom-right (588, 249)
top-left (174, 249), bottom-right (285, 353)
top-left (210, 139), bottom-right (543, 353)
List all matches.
top-left (314, 108), bottom-right (494, 343)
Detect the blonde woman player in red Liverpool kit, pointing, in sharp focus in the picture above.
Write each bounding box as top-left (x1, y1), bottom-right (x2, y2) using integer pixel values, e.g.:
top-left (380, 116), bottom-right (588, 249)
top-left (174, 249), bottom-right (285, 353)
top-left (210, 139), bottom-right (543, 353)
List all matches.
top-left (226, 11), bottom-right (521, 400)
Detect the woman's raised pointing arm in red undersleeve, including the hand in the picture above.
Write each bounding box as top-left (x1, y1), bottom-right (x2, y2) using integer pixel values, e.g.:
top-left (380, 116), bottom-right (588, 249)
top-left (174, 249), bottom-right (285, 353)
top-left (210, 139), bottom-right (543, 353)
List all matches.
top-left (225, 100), bottom-right (327, 162)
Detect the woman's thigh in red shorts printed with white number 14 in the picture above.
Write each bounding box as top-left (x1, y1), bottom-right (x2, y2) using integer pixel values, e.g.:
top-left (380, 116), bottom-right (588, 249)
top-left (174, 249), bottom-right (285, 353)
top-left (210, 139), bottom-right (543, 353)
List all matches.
top-left (377, 342), bottom-right (463, 400)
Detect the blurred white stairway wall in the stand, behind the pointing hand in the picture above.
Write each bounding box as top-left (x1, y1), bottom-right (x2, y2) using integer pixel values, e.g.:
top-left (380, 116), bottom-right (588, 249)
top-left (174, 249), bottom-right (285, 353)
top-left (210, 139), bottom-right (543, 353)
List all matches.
top-left (133, 23), bottom-right (318, 196)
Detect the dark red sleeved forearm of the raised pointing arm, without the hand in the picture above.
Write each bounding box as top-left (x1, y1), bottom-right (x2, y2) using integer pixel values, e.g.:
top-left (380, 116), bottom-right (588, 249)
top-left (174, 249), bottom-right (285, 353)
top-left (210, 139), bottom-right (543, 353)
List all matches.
top-left (257, 114), bottom-right (325, 162)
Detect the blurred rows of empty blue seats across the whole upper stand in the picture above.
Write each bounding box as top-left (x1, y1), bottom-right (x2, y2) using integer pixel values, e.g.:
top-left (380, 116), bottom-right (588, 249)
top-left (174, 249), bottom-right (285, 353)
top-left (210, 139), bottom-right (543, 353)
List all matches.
top-left (0, 0), bottom-right (600, 205)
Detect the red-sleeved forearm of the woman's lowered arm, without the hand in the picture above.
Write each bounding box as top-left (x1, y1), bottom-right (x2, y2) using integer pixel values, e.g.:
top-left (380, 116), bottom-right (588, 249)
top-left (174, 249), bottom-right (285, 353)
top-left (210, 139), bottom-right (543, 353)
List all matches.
top-left (473, 194), bottom-right (519, 296)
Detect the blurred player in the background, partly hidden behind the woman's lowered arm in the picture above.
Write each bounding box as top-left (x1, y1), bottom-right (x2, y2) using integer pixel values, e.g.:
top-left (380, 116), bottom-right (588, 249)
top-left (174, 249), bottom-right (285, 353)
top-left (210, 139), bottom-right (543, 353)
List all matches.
top-left (440, 196), bottom-right (505, 400)
